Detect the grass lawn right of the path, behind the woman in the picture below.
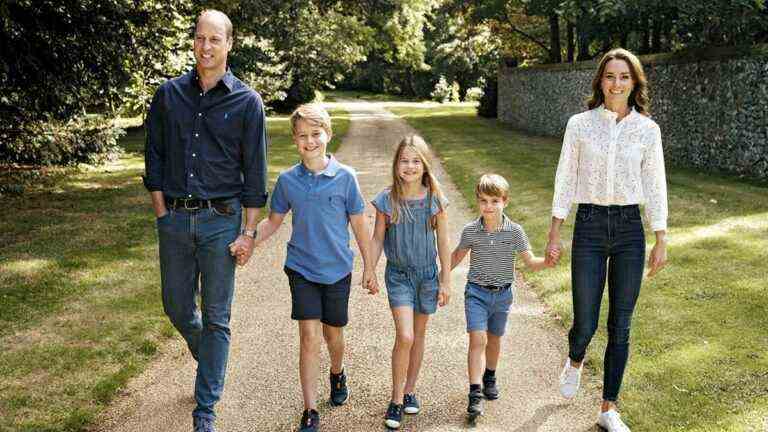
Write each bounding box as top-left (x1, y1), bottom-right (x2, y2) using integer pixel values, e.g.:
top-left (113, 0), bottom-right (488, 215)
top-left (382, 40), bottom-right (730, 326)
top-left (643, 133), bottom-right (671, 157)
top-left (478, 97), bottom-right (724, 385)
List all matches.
top-left (388, 105), bottom-right (768, 431)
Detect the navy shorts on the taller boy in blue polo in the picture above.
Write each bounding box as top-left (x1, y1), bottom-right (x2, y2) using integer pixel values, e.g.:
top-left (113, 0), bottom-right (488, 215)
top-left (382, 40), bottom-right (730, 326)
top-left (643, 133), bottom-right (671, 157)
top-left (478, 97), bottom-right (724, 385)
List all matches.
top-left (283, 267), bottom-right (352, 327)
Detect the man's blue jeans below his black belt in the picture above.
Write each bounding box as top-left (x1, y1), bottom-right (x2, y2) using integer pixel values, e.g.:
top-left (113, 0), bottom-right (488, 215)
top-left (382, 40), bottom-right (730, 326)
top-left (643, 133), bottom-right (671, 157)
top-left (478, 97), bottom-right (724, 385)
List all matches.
top-left (157, 198), bottom-right (242, 419)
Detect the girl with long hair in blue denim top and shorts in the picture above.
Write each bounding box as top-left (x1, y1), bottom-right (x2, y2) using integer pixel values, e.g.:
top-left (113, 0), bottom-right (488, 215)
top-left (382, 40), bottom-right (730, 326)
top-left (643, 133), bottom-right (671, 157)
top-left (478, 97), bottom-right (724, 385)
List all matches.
top-left (371, 135), bottom-right (451, 429)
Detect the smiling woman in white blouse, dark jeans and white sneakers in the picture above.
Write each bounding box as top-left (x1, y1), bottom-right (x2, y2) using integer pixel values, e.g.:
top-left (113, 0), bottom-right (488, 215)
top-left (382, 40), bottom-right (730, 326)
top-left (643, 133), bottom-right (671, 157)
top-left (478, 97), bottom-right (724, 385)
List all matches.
top-left (547, 49), bottom-right (667, 432)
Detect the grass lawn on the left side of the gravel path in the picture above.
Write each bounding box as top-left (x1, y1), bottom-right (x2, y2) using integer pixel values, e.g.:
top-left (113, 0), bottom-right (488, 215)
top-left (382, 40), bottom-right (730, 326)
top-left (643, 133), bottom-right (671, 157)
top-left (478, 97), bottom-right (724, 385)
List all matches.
top-left (0, 111), bottom-right (349, 432)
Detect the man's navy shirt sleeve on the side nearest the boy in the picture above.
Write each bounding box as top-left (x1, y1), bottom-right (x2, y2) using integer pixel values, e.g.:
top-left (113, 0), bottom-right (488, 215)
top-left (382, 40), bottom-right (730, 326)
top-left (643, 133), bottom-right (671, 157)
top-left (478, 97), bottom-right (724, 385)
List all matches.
top-left (241, 92), bottom-right (267, 207)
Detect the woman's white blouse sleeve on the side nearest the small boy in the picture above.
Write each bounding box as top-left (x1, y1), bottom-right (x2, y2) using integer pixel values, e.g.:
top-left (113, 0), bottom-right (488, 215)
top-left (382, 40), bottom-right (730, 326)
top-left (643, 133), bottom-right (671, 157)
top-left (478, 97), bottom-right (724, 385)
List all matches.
top-left (552, 116), bottom-right (579, 219)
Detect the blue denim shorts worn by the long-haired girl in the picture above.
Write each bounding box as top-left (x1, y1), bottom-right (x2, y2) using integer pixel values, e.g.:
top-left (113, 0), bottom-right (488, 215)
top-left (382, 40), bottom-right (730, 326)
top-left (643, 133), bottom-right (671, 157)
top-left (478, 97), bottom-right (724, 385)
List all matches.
top-left (384, 263), bottom-right (440, 315)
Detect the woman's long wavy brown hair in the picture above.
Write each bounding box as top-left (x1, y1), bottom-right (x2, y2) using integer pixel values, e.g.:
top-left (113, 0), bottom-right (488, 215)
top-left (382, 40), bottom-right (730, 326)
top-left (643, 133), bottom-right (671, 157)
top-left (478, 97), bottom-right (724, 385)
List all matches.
top-left (587, 48), bottom-right (651, 116)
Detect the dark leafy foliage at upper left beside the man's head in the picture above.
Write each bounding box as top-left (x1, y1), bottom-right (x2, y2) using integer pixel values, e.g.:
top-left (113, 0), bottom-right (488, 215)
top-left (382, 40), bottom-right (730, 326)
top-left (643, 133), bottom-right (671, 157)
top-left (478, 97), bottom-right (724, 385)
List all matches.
top-left (0, 0), bottom-right (191, 165)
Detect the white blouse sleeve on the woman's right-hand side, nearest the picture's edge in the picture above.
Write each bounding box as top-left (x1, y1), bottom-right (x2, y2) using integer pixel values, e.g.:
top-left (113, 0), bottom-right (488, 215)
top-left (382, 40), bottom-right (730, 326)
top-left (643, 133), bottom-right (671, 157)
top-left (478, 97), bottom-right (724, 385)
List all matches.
top-left (641, 125), bottom-right (668, 231)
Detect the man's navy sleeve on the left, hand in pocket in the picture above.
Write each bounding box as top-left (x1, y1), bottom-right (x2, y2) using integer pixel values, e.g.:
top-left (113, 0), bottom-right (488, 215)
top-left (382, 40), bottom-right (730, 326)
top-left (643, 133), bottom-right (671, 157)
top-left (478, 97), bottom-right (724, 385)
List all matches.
top-left (143, 86), bottom-right (165, 192)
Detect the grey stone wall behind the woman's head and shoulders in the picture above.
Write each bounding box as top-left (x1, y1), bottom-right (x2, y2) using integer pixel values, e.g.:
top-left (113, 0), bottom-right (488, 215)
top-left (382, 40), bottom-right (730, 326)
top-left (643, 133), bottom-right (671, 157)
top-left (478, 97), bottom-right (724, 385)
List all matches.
top-left (498, 46), bottom-right (768, 180)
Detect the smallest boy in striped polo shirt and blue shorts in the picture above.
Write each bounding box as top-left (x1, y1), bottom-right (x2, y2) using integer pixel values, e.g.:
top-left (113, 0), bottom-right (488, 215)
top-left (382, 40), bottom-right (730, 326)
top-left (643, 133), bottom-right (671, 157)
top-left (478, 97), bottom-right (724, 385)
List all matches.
top-left (451, 174), bottom-right (554, 418)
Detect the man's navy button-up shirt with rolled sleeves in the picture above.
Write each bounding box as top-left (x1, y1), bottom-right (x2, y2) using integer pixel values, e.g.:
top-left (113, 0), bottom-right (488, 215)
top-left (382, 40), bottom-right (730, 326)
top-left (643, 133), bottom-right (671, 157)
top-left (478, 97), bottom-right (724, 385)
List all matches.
top-left (144, 69), bottom-right (267, 207)
